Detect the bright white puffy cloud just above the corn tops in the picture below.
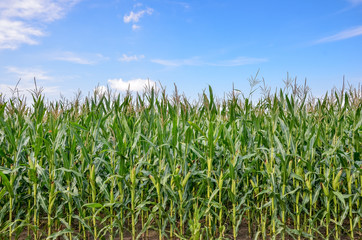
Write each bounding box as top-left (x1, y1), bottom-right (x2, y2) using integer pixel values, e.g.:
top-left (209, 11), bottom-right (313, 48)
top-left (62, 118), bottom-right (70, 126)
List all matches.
top-left (108, 78), bottom-right (157, 91)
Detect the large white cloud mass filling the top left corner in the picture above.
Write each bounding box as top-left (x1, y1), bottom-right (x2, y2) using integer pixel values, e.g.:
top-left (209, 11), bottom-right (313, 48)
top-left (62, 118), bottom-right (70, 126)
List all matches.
top-left (0, 0), bottom-right (81, 49)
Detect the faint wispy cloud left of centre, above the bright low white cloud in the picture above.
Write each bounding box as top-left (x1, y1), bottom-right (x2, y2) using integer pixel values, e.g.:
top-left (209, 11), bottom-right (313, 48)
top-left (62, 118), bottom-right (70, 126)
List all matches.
top-left (54, 52), bottom-right (107, 65)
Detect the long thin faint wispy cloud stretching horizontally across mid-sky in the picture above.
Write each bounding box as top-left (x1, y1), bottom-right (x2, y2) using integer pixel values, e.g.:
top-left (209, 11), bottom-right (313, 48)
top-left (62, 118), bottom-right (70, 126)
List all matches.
top-left (151, 57), bottom-right (268, 67)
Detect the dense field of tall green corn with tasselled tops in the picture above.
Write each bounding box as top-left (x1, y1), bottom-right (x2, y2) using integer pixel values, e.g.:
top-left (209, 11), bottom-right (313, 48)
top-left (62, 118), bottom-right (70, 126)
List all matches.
top-left (0, 83), bottom-right (362, 240)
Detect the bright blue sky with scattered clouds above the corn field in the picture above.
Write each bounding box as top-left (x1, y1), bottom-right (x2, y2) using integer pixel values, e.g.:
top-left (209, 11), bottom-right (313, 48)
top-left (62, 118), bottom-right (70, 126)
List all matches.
top-left (0, 0), bottom-right (362, 99)
